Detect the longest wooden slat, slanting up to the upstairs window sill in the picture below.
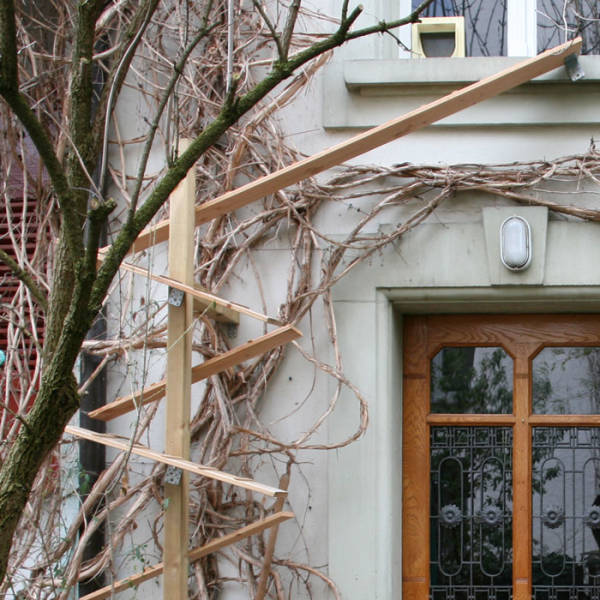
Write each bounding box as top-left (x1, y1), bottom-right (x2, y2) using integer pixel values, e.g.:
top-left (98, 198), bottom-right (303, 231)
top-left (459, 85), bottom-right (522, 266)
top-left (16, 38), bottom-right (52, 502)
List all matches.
top-left (127, 38), bottom-right (581, 252)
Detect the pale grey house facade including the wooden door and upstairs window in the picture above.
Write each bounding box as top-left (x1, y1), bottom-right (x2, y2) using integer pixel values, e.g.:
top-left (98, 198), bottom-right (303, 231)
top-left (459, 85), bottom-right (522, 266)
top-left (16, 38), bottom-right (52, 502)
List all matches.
top-left (96, 0), bottom-right (600, 600)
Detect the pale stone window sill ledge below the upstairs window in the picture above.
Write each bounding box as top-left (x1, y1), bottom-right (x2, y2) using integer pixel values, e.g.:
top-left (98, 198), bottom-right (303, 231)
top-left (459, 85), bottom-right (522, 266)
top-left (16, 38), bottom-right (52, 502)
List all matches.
top-left (323, 56), bottom-right (600, 129)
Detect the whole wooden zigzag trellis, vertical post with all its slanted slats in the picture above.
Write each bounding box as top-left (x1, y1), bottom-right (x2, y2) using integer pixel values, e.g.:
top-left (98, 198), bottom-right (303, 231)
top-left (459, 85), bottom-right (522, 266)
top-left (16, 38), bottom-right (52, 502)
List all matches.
top-left (66, 38), bottom-right (581, 600)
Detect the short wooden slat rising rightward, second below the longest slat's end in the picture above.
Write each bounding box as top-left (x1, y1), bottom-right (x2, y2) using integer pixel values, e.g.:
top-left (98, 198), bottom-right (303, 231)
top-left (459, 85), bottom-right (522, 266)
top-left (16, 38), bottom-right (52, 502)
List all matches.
top-left (88, 325), bottom-right (302, 421)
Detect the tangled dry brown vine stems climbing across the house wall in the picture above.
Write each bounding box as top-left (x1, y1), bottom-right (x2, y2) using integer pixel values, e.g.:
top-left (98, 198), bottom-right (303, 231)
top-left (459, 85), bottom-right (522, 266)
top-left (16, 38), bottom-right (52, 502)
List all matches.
top-left (0, 0), bottom-right (600, 599)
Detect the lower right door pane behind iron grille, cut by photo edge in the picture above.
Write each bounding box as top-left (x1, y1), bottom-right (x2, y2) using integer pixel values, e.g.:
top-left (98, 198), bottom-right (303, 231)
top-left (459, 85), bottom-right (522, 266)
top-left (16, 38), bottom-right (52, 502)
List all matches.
top-left (532, 427), bottom-right (600, 600)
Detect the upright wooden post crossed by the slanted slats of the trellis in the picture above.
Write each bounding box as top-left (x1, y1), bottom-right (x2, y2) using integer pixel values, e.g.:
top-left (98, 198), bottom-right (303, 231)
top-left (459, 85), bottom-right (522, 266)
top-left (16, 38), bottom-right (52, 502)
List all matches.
top-left (163, 140), bottom-right (195, 600)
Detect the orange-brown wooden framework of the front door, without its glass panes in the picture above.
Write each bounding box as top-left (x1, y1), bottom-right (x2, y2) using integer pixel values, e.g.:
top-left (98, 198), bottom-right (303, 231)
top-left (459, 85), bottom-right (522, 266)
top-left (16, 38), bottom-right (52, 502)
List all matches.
top-left (402, 314), bottom-right (600, 600)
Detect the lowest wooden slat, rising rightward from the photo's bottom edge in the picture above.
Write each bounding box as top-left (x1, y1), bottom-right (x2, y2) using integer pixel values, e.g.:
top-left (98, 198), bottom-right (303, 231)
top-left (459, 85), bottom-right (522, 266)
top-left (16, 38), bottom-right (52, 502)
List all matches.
top-left (80, 512), bottom-right (294, 600)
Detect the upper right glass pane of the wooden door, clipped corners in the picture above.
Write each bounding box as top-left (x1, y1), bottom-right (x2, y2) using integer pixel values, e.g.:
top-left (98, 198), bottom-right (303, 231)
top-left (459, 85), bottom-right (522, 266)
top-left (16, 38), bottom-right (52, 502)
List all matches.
top-left (533, 347), bottom-right (600, 415)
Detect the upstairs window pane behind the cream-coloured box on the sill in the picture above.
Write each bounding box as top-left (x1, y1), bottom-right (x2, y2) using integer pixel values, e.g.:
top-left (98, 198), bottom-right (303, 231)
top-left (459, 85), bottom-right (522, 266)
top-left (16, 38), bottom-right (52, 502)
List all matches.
top-left (412, 0), bottom-right (506, 56)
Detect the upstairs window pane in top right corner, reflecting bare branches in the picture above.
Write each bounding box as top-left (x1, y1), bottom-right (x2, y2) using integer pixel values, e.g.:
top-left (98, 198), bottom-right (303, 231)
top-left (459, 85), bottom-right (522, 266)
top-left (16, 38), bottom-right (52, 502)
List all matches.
top-left (537, 0), bottom-right (600, 54)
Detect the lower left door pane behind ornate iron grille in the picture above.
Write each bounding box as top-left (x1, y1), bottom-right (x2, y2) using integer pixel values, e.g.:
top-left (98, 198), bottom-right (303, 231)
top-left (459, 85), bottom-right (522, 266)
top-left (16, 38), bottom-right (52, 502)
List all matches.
top-left (430, 427), bottom-right (512, 600)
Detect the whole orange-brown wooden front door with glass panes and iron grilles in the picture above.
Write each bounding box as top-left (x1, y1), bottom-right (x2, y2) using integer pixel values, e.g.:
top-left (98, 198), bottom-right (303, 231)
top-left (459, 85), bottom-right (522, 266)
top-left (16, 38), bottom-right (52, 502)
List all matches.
top-left (402, 315), bottom-right (600, 600)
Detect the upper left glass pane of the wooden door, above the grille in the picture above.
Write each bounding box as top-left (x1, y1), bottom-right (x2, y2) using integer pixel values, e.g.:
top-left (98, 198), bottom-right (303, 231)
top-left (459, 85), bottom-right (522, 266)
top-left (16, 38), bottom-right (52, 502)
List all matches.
top-left (431, 347), bottom-right (513, 414)
